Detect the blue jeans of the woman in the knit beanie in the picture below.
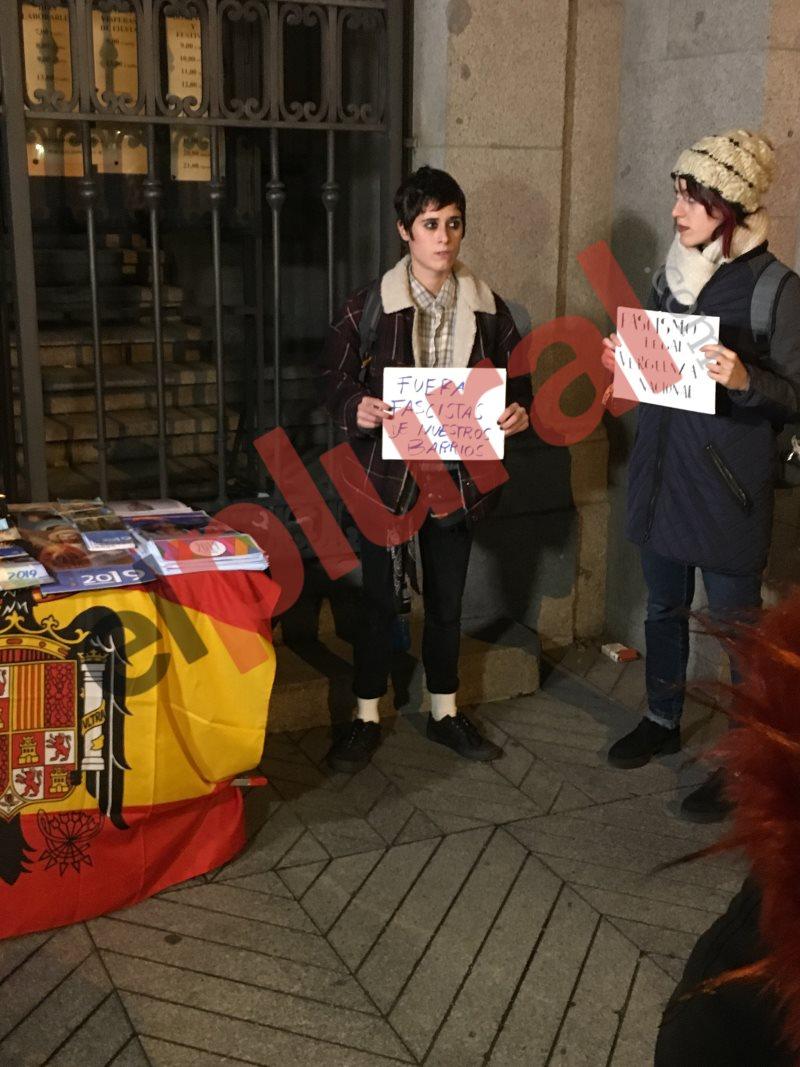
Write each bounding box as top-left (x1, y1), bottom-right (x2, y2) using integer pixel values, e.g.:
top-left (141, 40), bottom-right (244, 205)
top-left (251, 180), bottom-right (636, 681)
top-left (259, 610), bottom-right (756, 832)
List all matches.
top-left (641, 546), bottom-right (762, 727)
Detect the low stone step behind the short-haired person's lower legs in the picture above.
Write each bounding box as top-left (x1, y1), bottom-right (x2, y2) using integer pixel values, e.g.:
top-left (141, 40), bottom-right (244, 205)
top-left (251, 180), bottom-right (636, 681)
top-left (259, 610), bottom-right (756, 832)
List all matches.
top-left (269, 620), bottom-right (539, 733)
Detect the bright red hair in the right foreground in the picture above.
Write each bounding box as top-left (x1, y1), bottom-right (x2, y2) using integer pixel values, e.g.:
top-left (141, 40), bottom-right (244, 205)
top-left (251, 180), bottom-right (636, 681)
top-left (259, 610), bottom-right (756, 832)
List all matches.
top-left (692, 590), bottom-right (800, 1053)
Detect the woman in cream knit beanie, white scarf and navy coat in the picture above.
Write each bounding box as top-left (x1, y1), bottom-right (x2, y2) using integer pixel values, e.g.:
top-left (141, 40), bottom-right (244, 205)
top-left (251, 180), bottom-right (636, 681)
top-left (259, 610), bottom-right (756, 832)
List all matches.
top-left (603, 130), bottom-right (800, 821)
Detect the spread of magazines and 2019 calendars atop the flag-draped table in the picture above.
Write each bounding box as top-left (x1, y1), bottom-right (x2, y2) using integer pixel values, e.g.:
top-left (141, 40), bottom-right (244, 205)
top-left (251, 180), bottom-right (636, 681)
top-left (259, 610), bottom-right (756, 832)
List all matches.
top-left (0, 499), bottom-right (268, 595)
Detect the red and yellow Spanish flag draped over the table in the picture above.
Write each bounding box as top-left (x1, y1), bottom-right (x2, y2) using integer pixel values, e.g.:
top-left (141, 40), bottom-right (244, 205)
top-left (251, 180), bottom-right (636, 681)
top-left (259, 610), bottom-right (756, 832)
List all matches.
top-left (0, 572), bottom-right (279, 937)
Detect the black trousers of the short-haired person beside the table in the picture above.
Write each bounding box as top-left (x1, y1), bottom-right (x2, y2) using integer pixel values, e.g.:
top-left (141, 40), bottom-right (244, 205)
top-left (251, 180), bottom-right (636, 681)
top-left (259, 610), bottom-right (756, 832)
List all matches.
top-left (353, 515), bottom-right (473, 700)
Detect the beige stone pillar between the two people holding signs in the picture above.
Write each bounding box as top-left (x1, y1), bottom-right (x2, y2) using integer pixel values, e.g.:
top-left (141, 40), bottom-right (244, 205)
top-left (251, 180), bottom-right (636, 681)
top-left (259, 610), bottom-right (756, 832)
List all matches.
top-left (412, 0), bottom-right (622, 646)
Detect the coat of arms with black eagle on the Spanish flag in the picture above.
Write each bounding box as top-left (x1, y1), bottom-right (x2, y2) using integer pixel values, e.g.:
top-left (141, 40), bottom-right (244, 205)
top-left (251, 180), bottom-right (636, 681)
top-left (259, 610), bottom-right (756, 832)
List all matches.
top-left (0, 591), bottom-right (128, 882)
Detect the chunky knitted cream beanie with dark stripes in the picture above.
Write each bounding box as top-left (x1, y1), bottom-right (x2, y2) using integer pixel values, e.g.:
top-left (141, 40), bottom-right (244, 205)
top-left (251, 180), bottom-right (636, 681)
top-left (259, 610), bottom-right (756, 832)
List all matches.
top-left (672, 130), bottom-right (774, 213)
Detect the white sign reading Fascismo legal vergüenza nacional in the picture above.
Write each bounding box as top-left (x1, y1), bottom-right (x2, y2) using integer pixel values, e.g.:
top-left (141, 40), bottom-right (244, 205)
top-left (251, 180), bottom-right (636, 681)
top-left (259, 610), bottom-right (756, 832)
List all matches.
top-left (613, 307), bottom-right (719, 415)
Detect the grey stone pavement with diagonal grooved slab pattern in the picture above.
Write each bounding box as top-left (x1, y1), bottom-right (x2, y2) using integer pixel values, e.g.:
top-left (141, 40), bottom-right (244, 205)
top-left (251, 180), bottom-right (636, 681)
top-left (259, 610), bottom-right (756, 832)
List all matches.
top-left (0, 649), bottom-right (742, 1067)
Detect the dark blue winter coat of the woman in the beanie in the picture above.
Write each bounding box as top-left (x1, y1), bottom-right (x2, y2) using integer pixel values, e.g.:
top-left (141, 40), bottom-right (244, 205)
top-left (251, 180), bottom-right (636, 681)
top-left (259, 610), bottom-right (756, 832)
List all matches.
top-left (627, 243), bottom-right (800, 574)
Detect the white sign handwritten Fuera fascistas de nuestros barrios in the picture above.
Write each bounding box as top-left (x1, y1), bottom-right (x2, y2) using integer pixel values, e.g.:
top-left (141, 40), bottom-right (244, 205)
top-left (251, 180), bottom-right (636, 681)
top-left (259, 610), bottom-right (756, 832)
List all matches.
top-left (381, 367), bottom-right (507, 461)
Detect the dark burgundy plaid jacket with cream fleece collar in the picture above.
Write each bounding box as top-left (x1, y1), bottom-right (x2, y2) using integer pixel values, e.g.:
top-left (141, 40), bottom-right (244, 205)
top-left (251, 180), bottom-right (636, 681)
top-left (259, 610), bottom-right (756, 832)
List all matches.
top-left (322, 257), bottom-right (531, 520)
